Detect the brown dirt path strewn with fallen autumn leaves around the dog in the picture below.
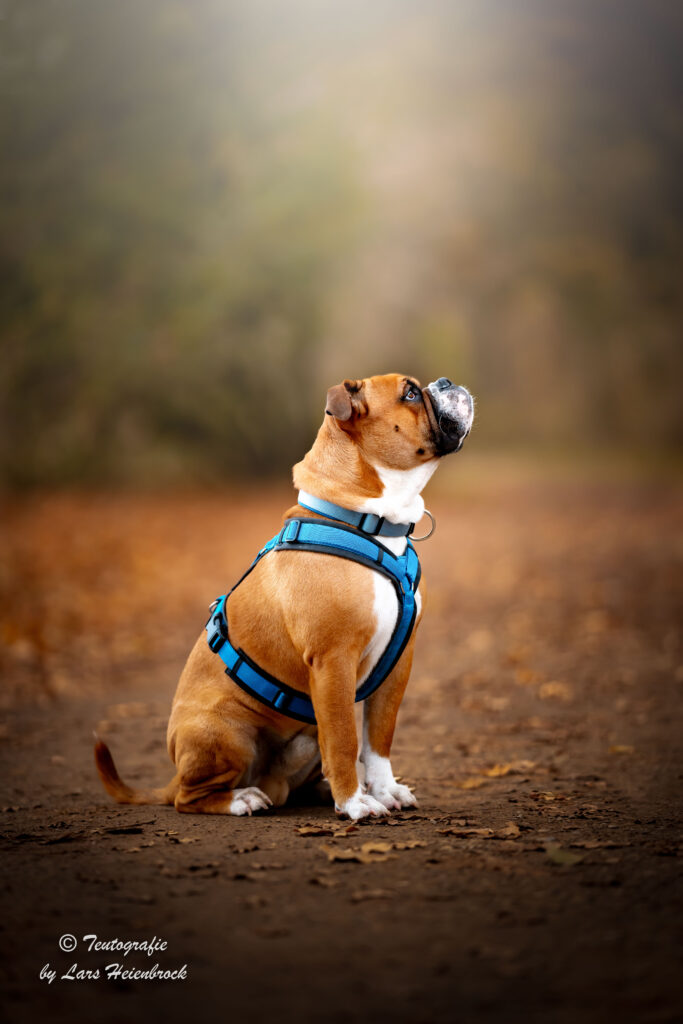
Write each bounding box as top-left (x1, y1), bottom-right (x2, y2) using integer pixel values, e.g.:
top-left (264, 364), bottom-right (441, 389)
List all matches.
top-left (0, 483), bottom-right (683, 1024)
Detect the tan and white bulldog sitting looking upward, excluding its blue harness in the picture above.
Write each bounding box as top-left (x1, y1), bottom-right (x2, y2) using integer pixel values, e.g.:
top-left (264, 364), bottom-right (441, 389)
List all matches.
top-left (95, 374), bottom-right (473, 819)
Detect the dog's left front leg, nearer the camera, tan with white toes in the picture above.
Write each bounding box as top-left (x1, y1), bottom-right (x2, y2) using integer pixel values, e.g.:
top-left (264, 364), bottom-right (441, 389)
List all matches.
top-left (310, 653), bottom-right (388, 820)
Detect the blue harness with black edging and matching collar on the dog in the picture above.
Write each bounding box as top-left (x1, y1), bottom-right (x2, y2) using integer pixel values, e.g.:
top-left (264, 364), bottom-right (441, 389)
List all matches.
top-left (206, 494), bottom-right (420, 723)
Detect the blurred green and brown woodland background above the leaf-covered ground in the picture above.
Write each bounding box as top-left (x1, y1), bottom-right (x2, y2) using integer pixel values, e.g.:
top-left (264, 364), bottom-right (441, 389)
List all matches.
top-left (0, 0), bottom-right (683, 486)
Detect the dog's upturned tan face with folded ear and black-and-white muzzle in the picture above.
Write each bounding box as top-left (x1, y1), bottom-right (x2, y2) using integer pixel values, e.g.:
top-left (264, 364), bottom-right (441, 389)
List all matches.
top-left (325, 374), bottom-right (474, 469)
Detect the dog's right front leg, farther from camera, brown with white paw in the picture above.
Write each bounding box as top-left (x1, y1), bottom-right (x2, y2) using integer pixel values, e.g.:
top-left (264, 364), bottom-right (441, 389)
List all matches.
top-left (360, 638), bottom-right (418, 810)
